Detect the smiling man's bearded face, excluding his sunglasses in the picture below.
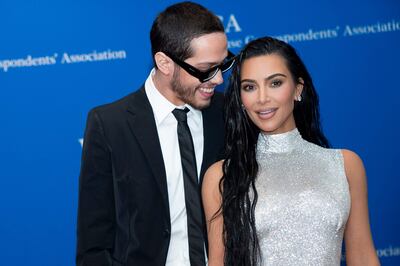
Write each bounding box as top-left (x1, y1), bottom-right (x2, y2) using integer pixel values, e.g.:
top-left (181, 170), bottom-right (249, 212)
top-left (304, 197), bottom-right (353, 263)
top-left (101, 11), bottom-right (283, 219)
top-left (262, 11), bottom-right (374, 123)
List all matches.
top-left (171, 32), bottom-right (228, 109)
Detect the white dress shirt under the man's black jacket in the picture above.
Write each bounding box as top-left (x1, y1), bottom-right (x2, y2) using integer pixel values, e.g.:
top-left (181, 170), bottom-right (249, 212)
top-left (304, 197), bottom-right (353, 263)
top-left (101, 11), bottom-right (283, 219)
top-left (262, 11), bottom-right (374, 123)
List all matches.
top-left (145, 69), bottom-right (204, 266)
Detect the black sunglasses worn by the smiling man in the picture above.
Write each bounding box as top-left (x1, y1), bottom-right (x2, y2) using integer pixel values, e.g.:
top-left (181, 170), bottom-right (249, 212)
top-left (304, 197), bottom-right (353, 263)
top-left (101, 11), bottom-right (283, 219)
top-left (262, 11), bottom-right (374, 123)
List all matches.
top-left (164, 51), bottom-right (236, 82)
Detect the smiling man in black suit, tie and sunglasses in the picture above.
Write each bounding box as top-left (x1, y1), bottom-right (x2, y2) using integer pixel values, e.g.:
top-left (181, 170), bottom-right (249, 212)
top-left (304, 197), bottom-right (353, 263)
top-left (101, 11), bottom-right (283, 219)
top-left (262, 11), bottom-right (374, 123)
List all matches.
top-left (77, 2), bottom-right (234, 266)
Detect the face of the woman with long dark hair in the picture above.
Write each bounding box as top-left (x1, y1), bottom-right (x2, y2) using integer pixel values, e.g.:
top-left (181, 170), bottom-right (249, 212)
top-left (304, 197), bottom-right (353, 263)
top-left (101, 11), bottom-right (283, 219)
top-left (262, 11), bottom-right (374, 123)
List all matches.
top-left (240, 54), bottom-right (303, 134)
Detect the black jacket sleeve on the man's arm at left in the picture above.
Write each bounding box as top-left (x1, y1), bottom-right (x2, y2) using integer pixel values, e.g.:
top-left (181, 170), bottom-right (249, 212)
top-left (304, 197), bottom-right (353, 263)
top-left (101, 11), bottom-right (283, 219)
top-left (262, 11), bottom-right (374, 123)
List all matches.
top-left (76, 110), bottom-right (115, 266)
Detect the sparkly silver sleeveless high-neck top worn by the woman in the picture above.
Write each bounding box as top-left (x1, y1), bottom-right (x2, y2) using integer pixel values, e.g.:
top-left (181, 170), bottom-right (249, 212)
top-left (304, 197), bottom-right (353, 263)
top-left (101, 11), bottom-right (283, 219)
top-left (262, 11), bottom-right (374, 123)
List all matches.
top-left (255, 129), bottom-right (350, 266)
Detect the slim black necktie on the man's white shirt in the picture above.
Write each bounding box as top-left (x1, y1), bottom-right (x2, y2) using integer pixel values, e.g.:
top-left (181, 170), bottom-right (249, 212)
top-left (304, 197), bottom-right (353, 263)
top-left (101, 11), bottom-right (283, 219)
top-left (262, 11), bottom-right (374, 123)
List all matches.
top-left (172, 107), bottom-right (205, 266)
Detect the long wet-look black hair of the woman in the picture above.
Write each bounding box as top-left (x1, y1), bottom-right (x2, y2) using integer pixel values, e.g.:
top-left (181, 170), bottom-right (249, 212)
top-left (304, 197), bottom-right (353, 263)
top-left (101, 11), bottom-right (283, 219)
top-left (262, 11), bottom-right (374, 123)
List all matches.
top-left (220, 37), bottom-right (329, 266)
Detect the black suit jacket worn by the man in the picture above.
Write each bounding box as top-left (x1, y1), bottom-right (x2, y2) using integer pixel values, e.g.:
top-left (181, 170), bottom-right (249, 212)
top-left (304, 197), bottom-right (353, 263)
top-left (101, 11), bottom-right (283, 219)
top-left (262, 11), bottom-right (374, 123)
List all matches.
top-left (76, 87), bottom-right (224, 266)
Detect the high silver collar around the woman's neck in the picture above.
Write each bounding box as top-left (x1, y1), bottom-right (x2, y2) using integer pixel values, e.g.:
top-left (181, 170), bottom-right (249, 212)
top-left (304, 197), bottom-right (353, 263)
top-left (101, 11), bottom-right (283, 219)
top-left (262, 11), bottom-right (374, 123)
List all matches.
top-left (257, 128), bottom-right (303, 153)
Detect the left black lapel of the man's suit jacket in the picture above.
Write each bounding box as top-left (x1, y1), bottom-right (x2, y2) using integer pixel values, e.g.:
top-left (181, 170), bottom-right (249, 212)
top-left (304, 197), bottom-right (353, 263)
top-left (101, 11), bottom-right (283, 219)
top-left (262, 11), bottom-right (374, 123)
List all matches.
top-left (127, 87), bottom-right (169, 215)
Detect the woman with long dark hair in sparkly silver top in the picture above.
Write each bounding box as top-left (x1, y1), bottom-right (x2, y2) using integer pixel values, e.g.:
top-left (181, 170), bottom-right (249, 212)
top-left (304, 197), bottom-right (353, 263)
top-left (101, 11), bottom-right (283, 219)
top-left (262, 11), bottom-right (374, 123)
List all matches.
top-left (202, 37), bottom-right (379, 266)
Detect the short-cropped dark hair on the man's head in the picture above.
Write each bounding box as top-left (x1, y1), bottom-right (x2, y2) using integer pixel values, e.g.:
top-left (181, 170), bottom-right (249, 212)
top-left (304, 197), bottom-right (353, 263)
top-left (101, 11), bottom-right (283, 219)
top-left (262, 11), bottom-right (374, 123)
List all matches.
top-left (150, 2), bottom-right (224, 66)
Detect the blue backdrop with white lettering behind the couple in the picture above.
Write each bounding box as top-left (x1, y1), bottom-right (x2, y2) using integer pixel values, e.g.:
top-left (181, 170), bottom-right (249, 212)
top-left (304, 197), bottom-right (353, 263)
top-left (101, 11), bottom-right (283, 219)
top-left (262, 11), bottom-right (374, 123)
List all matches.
top-left (0, 0), bottom-right (400, 266)
